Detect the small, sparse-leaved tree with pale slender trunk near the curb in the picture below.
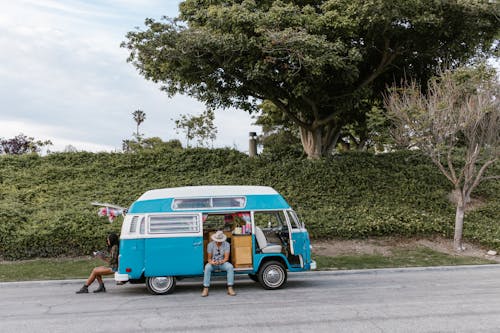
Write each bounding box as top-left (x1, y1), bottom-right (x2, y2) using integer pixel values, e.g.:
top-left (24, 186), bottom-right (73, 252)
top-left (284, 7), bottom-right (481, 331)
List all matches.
top-left (385, 66), bottom-right (500, 251)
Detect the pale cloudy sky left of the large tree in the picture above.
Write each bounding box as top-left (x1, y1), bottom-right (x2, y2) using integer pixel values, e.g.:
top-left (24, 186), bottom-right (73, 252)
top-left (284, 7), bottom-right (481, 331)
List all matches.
top-left (0, 0), bottom-right (260, 152)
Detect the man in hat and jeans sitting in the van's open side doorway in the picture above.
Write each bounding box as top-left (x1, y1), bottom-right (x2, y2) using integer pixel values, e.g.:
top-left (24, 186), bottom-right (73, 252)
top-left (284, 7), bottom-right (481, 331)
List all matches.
top-left (201, 230), bottom-right (236, 297)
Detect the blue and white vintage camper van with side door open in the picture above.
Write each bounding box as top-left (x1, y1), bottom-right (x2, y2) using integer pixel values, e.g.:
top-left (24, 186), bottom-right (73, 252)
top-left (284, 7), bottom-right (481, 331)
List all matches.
top-left (115, 186), bottom-right (316, 295)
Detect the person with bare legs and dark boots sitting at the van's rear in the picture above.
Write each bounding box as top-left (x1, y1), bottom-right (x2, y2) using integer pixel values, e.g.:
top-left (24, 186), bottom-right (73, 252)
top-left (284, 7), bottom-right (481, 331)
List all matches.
top-left (76, 233), bottom-right (119, 294)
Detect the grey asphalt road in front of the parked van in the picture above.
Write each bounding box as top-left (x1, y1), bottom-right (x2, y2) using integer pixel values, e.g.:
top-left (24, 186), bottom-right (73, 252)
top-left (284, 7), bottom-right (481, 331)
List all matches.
top-left (0, 265), bottom-right (500, 333)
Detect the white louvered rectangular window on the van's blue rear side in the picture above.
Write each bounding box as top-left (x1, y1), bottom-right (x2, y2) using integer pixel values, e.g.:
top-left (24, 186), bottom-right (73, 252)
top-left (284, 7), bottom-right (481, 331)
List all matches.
top-left (149, 214), bottom-right (200, 234)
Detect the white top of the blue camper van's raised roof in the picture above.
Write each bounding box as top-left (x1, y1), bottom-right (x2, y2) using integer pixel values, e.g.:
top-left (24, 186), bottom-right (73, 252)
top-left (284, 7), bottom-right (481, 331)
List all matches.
top-left (137, 185), bottom-right (279, 201)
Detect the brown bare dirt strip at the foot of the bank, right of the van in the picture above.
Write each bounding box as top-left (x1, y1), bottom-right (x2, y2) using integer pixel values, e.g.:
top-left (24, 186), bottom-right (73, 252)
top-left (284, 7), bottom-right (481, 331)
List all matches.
top-left (312, 237), bottom-right (500, 262)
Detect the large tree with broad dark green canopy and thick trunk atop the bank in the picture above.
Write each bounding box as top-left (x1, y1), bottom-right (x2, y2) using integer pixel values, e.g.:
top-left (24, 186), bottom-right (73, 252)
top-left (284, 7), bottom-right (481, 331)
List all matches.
top-left (123, 0), bottom-right (498, 158)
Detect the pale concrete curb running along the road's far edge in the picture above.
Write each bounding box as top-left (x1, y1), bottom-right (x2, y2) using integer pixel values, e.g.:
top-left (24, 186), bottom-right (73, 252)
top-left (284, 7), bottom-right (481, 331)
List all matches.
top-left (0, 264), bottom-right (500, 288)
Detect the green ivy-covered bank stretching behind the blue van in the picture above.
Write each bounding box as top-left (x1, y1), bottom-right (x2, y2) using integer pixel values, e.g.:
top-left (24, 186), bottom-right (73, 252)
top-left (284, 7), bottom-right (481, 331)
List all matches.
top-left (0, 149), bottom-right (500, 259)
